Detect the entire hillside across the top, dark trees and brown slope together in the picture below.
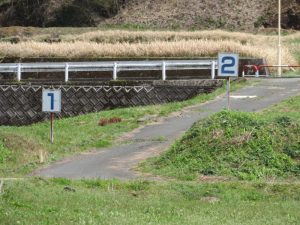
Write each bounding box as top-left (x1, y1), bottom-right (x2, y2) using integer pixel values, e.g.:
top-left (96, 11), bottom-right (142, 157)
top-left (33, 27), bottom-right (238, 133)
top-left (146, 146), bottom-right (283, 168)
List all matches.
top-left (0, 0), bottom-right (300, 30)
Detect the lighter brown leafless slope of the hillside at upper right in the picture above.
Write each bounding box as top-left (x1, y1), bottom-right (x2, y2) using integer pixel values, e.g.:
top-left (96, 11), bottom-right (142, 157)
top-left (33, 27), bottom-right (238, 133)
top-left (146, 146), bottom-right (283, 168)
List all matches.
top-left (109, 0), bottom-right (300, 30)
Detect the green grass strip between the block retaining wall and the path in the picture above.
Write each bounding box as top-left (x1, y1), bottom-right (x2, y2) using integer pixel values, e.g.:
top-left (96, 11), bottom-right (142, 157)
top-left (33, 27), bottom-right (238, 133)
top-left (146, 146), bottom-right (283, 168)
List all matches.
top-left (0, 79), bottom-right (249, 177)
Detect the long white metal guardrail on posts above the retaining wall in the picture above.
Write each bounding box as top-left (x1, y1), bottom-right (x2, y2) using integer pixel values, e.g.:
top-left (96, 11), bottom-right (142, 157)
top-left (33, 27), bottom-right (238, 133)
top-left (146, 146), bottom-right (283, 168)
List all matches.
top-left (0, 60), bottom-right (217, 82)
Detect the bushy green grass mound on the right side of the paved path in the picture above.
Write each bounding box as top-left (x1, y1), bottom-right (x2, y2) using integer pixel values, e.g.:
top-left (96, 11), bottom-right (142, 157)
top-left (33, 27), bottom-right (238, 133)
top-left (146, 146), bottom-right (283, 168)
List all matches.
top-left (143, 97), bottom-right (300, 180)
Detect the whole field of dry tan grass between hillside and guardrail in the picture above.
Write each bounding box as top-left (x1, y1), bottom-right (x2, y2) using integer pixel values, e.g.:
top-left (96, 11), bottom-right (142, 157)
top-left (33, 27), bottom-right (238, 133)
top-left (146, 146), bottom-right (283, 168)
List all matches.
top-left (0, 30), bottom-right (300, 64)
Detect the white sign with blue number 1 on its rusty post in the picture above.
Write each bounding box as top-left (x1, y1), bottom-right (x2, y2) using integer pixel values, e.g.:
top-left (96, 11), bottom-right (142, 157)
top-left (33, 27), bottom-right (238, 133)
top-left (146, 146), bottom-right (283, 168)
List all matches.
top-left (43, 89), bottom-right (61, 144)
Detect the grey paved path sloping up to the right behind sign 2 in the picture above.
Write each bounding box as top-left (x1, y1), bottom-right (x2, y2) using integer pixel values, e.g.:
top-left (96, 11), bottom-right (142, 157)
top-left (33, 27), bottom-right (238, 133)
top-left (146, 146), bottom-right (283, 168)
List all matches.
top-left (34, 79), bottom-right (300, 179)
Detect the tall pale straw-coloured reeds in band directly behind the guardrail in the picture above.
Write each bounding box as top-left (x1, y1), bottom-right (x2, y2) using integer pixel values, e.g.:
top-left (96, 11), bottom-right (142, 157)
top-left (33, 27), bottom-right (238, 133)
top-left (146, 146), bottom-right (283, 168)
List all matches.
top-left (0, 40), bottom-right (295, 64)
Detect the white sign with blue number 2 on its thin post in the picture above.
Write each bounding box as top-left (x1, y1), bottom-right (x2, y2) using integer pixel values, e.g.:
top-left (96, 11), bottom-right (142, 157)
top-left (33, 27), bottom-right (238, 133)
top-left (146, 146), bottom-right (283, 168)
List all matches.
top-left (218, 53), bottom-right (239, 110)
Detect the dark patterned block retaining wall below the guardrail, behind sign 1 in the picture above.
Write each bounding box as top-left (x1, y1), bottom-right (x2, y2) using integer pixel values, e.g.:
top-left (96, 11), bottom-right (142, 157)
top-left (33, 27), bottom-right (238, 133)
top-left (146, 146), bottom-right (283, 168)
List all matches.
top-left (0, 80), bottom-right (223, 126)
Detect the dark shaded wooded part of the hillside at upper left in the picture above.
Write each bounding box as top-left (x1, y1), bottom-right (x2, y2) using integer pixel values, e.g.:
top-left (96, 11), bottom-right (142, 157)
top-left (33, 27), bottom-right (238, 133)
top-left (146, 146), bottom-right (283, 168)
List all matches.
top-left (0, 0), bottom-right (123, 27)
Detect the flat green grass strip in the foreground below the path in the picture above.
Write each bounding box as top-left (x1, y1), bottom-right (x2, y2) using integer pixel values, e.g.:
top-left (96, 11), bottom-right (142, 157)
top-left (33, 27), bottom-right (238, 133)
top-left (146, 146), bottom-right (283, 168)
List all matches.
top-left (0, 179), bottom-right (300, 225)
